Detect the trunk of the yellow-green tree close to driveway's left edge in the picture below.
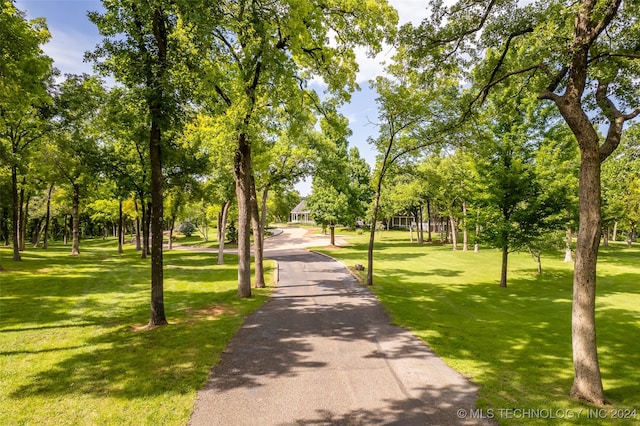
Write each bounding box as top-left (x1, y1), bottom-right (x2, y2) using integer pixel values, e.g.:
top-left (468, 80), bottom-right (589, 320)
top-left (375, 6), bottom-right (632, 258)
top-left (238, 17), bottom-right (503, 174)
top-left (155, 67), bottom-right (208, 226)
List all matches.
top-left (234, 132), bottom-right (252, 298)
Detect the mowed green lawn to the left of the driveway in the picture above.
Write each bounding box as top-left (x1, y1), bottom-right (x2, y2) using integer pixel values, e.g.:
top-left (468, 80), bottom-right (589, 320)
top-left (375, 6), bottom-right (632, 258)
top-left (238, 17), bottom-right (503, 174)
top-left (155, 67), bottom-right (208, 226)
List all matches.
top-left (0, 240), bottom-right (273, 425)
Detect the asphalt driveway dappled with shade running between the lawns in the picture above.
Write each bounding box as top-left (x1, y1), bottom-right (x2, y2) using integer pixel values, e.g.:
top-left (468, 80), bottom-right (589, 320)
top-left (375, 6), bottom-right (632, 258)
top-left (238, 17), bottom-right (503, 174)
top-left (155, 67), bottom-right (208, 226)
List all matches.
top-left (190, 232), bottom-right (488, 426)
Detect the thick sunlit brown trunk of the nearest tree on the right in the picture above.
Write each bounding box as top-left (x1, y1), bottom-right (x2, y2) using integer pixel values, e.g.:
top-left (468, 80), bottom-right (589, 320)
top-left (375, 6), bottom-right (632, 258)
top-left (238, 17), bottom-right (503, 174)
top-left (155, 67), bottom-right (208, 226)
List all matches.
top-left (571, 148), bottom-right (605, 405)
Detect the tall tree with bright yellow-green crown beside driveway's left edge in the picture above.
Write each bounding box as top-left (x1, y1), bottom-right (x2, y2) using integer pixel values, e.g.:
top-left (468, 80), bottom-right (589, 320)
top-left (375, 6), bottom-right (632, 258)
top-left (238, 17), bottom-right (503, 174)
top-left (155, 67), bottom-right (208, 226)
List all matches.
top-left (190, 0), bottom-right (397, 297)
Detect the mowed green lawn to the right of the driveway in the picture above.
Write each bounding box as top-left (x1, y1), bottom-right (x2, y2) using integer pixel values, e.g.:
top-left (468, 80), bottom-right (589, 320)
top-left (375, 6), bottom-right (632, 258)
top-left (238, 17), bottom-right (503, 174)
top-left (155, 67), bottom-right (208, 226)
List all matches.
top-left (316, 231), bottom-right (640, 425)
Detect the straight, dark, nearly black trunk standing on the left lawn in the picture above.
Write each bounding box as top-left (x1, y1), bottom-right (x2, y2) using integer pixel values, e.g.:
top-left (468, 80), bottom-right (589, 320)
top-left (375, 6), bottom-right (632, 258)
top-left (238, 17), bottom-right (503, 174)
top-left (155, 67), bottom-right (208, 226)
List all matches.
top-left (149, 121), bottom-right (167, 327)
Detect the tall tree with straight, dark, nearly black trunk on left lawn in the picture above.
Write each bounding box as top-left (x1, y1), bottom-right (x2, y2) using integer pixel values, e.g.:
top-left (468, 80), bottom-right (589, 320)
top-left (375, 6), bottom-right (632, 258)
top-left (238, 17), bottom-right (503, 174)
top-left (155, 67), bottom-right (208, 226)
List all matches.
top-left (88, 0), bottom-right (193, 327)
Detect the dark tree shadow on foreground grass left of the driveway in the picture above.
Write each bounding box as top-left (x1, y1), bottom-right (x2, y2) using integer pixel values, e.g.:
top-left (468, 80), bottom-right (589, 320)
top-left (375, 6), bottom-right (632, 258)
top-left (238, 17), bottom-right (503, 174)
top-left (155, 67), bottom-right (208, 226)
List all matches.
top-left (10, 291), bottom-right (257, 400)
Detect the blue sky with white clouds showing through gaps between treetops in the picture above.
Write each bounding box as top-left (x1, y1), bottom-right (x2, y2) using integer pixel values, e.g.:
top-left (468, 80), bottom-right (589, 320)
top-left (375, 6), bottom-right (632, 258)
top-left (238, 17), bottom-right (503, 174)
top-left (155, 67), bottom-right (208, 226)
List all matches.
top-left (16, 0), bottom-right (427, 195)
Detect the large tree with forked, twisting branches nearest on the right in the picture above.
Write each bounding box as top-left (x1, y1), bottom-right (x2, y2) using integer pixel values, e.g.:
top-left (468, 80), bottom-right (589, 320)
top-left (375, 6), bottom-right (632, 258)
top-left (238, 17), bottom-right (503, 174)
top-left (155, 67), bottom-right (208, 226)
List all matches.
top-left (405, 0), bottom-right (640, 404)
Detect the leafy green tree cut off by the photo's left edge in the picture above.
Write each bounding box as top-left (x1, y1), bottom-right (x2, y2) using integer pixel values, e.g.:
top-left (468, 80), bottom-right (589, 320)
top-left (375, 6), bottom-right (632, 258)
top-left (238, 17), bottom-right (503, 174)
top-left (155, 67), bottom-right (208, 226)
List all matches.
top-left (0, 0), bottom-right (52, 261)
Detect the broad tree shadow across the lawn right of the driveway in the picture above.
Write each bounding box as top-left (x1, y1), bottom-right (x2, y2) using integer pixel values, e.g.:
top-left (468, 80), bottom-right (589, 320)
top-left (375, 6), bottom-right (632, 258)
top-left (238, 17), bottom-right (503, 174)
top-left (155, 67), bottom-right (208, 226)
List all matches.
top-left (374, 269), bottom-right (640, 418)
